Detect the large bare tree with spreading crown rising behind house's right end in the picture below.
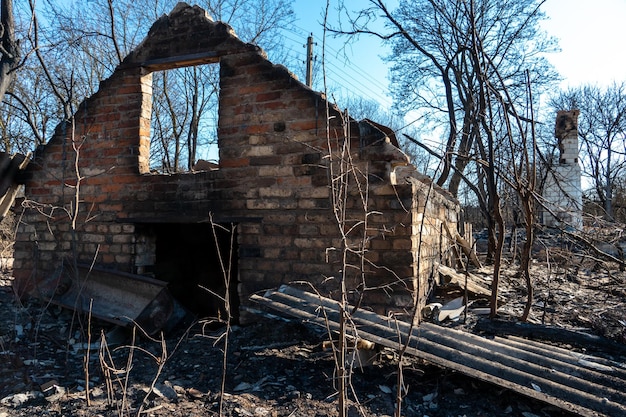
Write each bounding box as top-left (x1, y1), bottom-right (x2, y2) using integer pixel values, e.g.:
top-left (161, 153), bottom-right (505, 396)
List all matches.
top-left (346, 0), bottom-right (556, 192)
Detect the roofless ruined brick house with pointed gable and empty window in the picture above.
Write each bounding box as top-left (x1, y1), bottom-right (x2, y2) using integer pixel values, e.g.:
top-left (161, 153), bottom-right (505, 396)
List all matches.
top-left (13, 3), bottom-right (458, 319)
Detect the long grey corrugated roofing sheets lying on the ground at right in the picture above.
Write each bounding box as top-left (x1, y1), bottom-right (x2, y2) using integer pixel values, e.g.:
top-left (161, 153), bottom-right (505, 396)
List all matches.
top-left (252, 286), bottom-right (626, 417)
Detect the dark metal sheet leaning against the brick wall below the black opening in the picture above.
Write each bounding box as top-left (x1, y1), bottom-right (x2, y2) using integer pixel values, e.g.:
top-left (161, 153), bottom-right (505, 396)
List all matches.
top-left (31, 264), bottom-right (186, 335)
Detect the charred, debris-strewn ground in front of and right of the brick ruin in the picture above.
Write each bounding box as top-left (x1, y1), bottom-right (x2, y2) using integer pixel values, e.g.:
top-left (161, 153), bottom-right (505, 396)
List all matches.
top-left (0, 258), bottom-right (626, 417)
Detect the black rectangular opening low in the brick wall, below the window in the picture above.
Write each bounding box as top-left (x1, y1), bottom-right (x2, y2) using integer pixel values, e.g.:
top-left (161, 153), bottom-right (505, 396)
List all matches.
top-left (138, 223), bottom-right (239, 322)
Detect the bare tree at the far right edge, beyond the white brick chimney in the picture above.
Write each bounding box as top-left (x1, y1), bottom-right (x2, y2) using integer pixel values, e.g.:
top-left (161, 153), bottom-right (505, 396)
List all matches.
top-left (551, 82), bottom-right (626, 221)
